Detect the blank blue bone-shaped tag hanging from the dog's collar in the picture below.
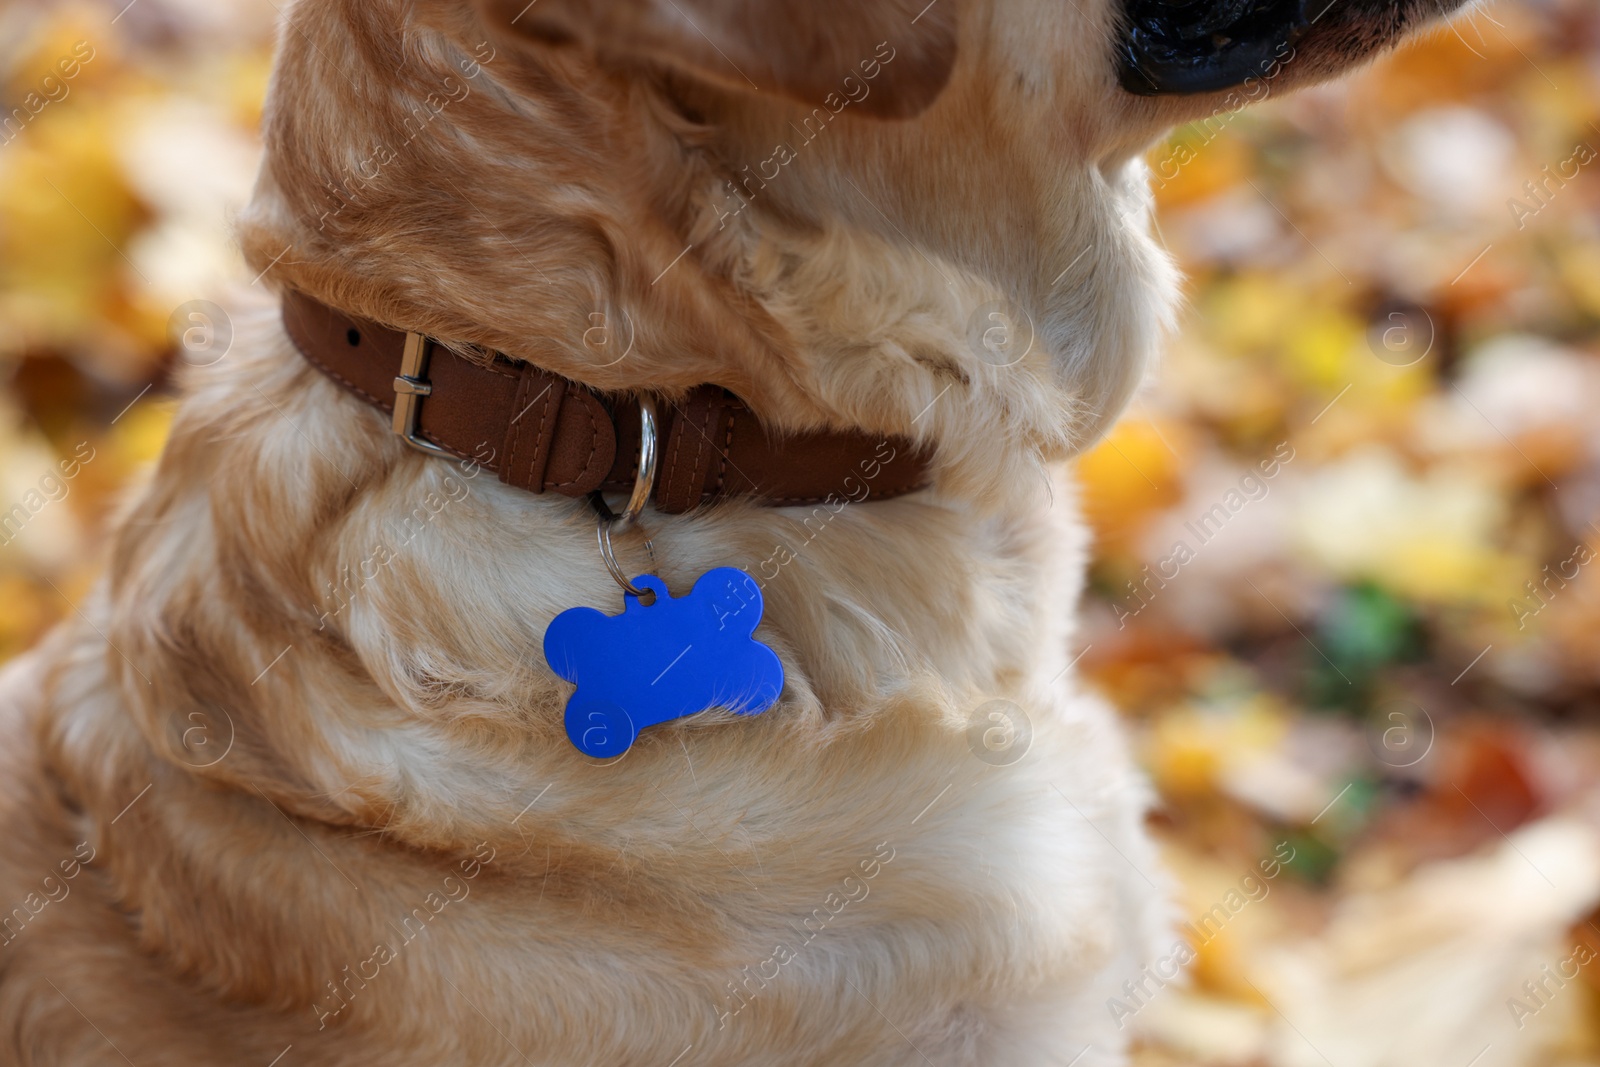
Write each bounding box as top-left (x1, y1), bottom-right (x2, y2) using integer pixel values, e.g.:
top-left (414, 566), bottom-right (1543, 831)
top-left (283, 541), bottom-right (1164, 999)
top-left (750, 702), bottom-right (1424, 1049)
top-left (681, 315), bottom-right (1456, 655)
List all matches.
top-left (544, 566), bottom-right (784, 760)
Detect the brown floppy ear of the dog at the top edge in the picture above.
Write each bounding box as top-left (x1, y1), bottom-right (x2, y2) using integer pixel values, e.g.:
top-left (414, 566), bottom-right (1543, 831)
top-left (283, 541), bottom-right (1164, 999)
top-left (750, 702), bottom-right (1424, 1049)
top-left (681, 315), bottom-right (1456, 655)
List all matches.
top-left (477, 0), bottom-right (958, 118)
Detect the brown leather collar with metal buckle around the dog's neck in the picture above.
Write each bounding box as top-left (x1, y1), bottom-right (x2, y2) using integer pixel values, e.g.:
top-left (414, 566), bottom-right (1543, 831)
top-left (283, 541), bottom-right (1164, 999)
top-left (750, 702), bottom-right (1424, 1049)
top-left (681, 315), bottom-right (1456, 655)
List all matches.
top-left (283, 291), bottom-right (930, 514)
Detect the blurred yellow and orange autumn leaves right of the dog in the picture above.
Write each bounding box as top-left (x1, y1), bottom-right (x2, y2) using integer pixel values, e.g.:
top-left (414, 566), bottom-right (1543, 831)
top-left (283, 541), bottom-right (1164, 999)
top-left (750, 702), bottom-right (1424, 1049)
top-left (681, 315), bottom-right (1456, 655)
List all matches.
top-left (1078, 2), bottom-right (1600, 1067)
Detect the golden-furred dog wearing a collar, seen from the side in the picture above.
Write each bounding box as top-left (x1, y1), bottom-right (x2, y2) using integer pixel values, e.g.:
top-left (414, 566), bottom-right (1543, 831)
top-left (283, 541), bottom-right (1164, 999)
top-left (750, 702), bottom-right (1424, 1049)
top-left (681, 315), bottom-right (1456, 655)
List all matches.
top-left (0, 0), bottom-right (1453, 1067)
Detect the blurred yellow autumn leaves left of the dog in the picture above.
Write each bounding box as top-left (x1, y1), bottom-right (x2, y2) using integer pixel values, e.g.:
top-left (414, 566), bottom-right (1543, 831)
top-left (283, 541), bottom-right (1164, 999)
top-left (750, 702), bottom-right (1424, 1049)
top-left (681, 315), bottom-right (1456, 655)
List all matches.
top-left (0, 0), bottom-right (270, 656)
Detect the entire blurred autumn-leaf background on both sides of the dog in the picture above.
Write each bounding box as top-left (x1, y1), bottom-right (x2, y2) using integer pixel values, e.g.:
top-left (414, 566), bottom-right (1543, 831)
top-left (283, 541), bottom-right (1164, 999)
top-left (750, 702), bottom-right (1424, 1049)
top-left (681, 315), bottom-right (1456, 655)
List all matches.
top-left (0, 0), bottom-right (1600, 1067)
